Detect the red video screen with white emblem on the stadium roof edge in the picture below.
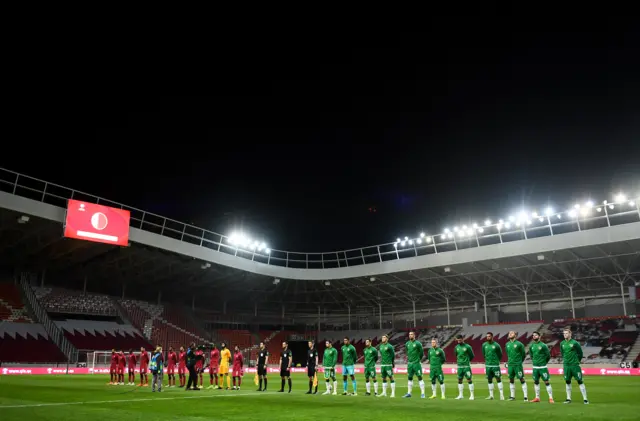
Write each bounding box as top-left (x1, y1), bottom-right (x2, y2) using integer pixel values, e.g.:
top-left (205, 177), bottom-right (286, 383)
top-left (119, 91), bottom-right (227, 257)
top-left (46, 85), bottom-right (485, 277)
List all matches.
top-left (64, 199), bottom-right (131, 246)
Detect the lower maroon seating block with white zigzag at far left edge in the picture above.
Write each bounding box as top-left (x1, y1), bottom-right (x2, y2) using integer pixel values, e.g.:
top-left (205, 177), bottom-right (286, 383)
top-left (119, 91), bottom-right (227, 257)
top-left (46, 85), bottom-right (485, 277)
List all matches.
top-left (0, 321), bottom-right (66, 363)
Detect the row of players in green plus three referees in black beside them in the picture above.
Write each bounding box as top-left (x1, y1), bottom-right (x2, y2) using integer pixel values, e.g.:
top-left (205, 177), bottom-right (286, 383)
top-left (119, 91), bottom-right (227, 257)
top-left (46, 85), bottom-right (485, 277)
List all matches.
top-left (268, 328), bottom-right (589, 404)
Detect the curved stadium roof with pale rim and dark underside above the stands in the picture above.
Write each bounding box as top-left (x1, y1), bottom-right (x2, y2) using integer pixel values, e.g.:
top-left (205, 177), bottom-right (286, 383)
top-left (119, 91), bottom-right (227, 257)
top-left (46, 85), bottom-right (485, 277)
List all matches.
top-left (0, 166), bottom-right (640, 313)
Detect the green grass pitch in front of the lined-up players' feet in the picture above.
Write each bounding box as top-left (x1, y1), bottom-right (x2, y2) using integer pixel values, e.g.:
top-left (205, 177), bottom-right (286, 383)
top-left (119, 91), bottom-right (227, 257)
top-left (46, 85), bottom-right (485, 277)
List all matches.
top-left (0, 375), bottom-right (640, 421)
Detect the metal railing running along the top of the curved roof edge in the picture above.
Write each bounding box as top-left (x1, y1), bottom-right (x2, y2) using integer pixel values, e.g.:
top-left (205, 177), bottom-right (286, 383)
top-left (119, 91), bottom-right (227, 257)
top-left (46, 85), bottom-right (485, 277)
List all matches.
top-left (0, 168), bottom-right (640, 269)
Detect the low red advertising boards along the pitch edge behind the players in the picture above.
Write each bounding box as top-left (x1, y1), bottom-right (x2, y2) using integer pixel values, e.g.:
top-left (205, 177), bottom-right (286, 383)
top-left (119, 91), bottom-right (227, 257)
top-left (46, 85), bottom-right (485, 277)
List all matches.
top-left (0, 366), bottom-right (640, 376)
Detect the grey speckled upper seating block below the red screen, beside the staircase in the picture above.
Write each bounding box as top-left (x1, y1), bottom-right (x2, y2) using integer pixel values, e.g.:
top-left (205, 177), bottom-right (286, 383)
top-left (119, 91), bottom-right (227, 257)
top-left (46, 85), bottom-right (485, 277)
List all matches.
top-left (33, 287), bottom-right (117, 316)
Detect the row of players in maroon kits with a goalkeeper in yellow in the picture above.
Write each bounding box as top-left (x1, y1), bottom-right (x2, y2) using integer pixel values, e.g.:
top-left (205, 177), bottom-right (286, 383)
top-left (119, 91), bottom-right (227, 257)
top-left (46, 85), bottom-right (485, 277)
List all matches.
top-left (109, 342), bottom-right (245, 390)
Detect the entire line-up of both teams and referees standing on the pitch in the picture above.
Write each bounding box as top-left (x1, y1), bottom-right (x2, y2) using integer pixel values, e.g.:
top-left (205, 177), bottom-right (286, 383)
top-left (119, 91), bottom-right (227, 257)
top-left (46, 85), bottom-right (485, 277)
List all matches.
top-left (110, 328), bottom-right (589, 404)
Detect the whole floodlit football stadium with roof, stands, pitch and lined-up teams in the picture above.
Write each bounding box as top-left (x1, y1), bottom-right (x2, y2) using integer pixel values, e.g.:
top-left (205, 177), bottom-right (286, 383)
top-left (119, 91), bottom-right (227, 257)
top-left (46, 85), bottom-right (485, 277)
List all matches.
top-left (0, 165), bottom-right (640, 420)
